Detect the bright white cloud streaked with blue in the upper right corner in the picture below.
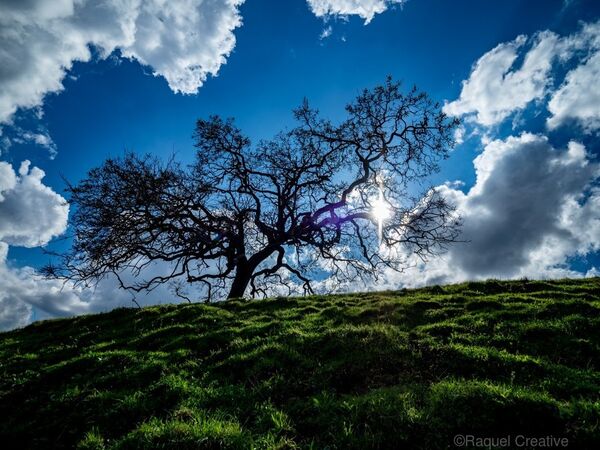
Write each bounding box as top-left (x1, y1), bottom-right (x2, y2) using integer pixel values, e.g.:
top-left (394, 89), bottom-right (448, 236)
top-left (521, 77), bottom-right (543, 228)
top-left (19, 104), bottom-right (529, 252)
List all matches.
top-left (444, 22), bottom-right (600, 131)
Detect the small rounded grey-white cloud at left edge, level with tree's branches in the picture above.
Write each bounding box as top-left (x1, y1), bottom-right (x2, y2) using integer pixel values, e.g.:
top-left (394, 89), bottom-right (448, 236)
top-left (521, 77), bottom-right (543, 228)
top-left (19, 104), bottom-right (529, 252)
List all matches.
top-left (0, 161), bottom-right (69, 247)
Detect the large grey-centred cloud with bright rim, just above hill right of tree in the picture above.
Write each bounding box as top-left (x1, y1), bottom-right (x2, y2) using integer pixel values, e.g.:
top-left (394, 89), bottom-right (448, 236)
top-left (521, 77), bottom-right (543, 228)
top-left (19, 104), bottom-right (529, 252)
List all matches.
top-left (380, 133), bottom-right (600, 288)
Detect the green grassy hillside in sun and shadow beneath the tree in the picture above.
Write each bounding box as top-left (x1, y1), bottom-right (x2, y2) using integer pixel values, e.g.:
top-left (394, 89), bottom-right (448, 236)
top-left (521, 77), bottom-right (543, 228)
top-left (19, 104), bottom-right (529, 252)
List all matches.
top-left (0, 278), bottom-right (600, 449)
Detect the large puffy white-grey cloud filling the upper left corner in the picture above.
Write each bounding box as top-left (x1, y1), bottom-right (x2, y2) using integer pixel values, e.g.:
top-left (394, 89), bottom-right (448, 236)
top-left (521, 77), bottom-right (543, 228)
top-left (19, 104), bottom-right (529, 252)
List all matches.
top-left (0, 0), bottom-right (244, 123)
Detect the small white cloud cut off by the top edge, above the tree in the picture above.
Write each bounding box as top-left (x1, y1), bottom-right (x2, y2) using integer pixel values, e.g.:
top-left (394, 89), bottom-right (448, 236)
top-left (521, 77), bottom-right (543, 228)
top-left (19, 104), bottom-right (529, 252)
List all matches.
top-left (307, 0), bottom-right (406, 25)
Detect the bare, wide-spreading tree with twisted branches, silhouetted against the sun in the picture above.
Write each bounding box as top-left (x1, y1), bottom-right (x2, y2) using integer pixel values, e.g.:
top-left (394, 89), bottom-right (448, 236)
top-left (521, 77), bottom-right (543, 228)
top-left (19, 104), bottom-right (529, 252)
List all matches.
top-left (46, 78), bottom-right (460, 300)
